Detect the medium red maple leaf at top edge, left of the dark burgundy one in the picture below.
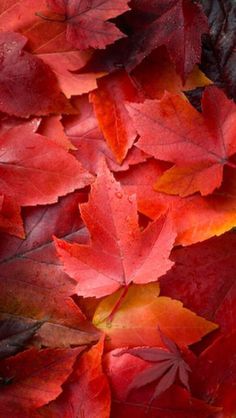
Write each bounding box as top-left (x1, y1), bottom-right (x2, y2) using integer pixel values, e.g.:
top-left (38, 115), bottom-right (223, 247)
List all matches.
top-left (47, 0), bottom-right (129, 49)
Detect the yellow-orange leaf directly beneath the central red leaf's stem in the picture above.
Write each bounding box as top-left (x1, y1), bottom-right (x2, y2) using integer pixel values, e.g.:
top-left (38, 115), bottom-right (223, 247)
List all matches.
top-left (93, 283), bottom-right (217, 349)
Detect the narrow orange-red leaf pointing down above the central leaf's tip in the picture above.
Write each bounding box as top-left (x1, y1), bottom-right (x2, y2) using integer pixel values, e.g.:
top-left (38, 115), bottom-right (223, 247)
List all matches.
top-left (90, 71), bottom-right (140, 163)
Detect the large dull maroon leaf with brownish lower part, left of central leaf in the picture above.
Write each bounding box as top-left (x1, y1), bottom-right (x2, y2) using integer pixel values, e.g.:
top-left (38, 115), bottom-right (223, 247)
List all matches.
top-left (0, 192), bottom-right (100, 347)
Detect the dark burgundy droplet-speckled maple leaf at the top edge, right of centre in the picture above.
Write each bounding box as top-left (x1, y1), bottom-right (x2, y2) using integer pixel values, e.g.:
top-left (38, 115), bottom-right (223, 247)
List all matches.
top-left (128, 0), bottom-right (208, 80)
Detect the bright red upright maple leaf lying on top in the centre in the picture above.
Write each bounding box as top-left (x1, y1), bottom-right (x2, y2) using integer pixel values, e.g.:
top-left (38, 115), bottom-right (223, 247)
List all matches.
top-left (55, 164), bottom-right (175, 297)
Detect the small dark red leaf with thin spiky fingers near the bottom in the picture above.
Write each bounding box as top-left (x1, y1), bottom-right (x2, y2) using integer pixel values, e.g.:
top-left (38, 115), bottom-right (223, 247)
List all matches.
top-left (119, 332), bottom-right (191, 403)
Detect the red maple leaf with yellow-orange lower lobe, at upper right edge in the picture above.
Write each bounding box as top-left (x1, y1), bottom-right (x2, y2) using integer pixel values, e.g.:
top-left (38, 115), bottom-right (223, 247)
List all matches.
top-left (127, 87), bottom-right (236, 196)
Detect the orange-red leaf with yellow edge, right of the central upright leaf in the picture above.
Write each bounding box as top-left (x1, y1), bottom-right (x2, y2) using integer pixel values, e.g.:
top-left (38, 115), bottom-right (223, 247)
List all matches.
top-left (117, 160), bottom-right (236, 245)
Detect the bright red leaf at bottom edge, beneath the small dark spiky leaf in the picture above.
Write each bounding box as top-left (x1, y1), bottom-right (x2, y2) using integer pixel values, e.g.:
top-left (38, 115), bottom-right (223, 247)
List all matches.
top-left (104, 348), bottom-right (221, 418)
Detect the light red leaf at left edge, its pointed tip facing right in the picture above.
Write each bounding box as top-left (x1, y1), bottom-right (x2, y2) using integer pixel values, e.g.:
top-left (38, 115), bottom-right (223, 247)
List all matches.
top-left (0, 121), bottom-right (93, 206)
